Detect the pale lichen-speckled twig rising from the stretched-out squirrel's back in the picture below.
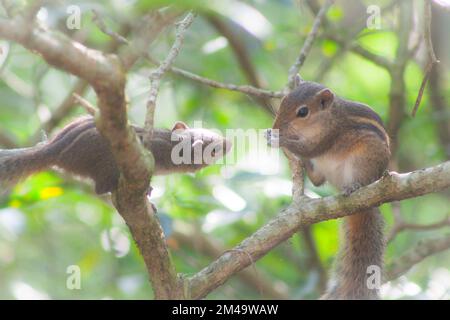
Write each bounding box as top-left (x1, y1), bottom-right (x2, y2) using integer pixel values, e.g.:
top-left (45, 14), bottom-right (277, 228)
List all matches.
top-left (144, 13), bottom-right (196, 144)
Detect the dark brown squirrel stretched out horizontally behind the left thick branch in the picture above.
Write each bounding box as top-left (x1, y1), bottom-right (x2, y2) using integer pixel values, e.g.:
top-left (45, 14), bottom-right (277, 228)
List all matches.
top-left (0, 117), bottom-right (231, 194)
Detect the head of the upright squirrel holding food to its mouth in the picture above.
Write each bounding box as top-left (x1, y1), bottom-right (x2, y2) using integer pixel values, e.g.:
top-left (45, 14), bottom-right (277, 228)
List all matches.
top-left (270, 81), bottom-right (335, 156)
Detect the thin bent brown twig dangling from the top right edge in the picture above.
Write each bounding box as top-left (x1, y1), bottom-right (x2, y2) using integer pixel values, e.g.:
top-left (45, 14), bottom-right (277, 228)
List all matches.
top-left (411, 0), bottom-right (439, 117)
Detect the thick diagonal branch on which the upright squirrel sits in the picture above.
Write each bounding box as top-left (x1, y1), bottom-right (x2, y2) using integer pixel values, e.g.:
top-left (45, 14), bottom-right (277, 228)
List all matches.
top-left (189, 162), bottom-right (450, 298)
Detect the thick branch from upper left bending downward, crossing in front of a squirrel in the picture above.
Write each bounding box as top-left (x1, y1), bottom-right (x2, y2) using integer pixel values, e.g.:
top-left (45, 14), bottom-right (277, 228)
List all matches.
top-left (0, 11), bottom-right (180, 299)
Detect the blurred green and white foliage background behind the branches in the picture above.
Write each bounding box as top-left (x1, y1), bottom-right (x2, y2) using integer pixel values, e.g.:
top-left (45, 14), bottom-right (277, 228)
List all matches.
top-left (0, 0), bottom-right (450, 299)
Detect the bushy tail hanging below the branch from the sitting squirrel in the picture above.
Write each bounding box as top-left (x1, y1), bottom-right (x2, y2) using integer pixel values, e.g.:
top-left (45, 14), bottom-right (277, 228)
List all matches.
top-left (322, 208), bottom-right (385, 300)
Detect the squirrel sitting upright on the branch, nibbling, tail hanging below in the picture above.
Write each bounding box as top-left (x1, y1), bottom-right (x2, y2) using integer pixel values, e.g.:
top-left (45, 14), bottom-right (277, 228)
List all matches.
top-left (267, 81), bottom-right (390, 299)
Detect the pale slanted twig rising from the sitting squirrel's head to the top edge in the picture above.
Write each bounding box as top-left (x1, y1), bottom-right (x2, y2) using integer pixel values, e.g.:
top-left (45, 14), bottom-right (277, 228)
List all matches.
top-left (286, 0), bottom-right (334, 91)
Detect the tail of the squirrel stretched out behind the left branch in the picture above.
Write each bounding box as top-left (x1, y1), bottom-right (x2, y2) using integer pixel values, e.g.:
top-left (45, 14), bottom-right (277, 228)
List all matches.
top-left (0, 145), bottom-right (49, 195)
